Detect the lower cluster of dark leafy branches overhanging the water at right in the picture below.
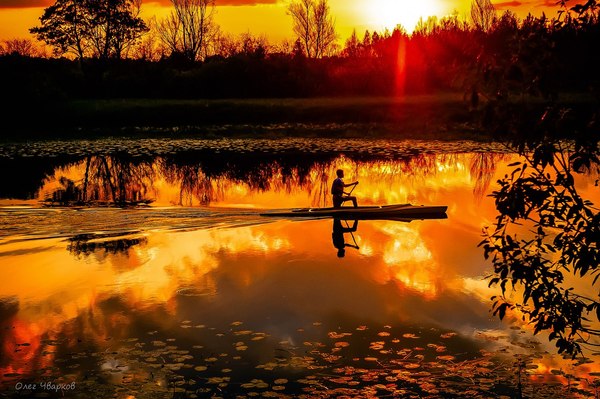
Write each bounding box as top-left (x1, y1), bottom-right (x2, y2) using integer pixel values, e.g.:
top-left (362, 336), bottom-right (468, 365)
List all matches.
top-left (482, 143), bottom-right (600, 353)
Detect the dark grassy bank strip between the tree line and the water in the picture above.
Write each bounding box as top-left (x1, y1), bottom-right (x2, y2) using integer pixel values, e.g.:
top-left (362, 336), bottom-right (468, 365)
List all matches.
top-left (2, 93), bottom-right (586, 139)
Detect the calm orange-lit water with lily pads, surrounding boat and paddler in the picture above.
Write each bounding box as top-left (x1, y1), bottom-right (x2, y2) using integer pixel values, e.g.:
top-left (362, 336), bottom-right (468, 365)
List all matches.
top-left (0, 139), bottom-right (600, 398)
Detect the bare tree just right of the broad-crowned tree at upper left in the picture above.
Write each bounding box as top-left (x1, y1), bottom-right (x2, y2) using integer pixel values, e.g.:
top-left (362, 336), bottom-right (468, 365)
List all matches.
top-left (156, 0), bottom-right (217, 61)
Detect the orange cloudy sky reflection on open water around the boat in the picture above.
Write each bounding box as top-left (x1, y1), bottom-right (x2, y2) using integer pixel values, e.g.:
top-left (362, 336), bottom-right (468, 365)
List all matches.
top-left (0, 155), bottom-right (600, 390)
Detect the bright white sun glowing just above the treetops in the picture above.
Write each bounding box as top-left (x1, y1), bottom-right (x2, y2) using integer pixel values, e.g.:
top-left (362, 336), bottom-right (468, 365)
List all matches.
top-left (365, 0), bottom-right (441, 32)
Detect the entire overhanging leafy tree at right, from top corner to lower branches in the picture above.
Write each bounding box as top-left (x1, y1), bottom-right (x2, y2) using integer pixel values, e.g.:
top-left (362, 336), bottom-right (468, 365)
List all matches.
top-left (481, 1), bottom-right (600, 355)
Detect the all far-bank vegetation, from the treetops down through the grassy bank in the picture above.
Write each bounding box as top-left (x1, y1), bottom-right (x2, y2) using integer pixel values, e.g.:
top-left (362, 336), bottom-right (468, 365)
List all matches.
top-left (0, 0), bottom-right (600, 136)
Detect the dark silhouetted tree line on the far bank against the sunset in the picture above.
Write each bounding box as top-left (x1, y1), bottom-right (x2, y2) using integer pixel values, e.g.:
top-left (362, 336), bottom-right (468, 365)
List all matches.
top-left (0, 0), bottom-right (600, 101)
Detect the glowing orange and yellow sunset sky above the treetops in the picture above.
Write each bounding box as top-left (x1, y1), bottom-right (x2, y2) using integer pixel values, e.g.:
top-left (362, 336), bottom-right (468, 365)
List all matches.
top-left (0, 0), bottom-right (556, 43)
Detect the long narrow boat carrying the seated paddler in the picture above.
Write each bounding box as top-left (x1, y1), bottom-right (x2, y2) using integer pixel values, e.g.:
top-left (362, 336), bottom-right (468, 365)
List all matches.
top-left (260, 204), bottom-right (448, 220)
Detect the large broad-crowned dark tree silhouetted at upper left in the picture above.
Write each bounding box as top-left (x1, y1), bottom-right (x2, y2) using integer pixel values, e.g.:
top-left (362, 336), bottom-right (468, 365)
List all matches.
top-left (30, 0), bottom-right (148, 59)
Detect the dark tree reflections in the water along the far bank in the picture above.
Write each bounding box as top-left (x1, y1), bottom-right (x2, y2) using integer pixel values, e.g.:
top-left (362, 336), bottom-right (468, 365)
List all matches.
top-left (27, 150), bottom-right (503, 207)
